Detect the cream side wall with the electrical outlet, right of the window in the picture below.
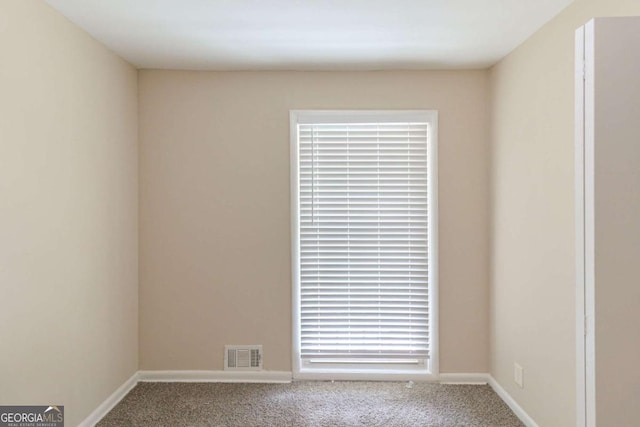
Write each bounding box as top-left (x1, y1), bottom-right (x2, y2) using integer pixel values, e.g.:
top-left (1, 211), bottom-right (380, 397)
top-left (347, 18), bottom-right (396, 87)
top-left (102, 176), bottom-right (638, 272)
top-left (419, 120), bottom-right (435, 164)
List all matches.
top-left (490, 0), bottom-right (640, 427)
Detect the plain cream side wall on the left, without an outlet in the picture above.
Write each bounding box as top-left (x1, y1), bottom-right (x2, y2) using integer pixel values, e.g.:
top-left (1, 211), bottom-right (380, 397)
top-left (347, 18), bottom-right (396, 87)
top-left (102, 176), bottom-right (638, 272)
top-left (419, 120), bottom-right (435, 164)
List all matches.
top-left (0, 0), bottom-right (138, 426)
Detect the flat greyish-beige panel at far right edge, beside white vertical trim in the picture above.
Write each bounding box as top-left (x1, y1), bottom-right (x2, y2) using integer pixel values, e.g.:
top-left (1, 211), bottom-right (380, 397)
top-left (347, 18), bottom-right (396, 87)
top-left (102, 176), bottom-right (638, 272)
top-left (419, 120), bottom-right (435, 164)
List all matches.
top-left (585, 18), bottom-right (640, 426)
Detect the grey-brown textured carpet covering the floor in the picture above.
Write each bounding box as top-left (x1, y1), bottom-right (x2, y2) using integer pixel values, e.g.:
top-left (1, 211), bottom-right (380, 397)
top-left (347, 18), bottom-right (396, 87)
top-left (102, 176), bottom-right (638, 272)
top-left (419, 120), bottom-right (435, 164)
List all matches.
top-left (97, 381), bottom-right (523, 427)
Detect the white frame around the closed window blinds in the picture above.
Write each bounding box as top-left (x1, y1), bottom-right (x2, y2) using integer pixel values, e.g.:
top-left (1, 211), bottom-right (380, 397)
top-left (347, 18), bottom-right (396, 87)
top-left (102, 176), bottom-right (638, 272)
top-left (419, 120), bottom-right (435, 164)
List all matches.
top-left (289, 110), bottom-right (439, 381)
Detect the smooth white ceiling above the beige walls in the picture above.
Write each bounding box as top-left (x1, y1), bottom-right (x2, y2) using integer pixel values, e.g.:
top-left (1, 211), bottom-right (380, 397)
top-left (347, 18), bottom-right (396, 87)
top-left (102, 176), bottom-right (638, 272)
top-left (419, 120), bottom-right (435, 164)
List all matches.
top-left (46, 0), bottom-right (573, 70)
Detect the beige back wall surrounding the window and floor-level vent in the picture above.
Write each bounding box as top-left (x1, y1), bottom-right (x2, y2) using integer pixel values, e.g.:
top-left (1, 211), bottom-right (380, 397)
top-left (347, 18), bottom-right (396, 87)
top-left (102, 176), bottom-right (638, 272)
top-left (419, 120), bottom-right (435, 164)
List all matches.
top-left (139, 71), bottom-right (489, 372)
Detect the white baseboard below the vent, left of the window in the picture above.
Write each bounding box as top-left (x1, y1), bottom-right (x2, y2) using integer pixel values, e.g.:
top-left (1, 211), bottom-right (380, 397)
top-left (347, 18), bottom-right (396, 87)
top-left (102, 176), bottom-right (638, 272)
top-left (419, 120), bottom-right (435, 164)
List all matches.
top-left (138, 371), bottom-right (291, 383)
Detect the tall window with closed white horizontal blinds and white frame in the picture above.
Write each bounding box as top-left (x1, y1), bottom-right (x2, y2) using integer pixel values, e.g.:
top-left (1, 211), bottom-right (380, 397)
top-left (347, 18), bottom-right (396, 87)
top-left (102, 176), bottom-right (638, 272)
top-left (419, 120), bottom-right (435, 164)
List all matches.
top-left (291, 111), bottom-right (437, 379)
